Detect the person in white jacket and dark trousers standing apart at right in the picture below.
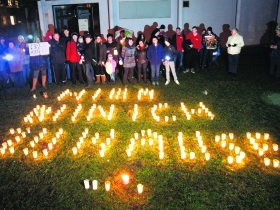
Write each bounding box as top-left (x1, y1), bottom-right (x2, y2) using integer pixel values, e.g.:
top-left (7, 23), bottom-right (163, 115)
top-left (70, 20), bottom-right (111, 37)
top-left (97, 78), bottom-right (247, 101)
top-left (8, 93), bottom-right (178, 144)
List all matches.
top-left (226, 28), bottom-right (244, 75)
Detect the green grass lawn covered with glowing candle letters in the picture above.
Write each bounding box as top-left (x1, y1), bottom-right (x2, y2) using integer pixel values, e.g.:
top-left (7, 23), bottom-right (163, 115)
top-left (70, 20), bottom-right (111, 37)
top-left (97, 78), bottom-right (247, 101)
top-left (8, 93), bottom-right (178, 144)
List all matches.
top-left (0, 46), bottom-right (280, 209)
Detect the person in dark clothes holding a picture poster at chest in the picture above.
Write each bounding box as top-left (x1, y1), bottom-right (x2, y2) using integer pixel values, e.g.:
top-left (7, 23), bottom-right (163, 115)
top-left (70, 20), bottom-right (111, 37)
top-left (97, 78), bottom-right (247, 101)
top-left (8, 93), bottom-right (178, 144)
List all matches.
top-left (201, 27), bottom-right (220, 70)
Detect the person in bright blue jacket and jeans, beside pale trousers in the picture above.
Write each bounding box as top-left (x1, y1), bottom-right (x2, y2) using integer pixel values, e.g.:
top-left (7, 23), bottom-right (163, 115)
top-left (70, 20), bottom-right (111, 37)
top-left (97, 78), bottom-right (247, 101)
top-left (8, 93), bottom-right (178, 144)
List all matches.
top-left (147, 36), bottom-right (164, 86)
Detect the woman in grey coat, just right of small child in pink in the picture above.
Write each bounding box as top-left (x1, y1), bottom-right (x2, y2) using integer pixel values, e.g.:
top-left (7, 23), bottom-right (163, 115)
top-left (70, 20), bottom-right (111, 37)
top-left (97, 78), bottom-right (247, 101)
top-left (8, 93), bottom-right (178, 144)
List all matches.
top-left (121, 38), bottom-right (136, 86)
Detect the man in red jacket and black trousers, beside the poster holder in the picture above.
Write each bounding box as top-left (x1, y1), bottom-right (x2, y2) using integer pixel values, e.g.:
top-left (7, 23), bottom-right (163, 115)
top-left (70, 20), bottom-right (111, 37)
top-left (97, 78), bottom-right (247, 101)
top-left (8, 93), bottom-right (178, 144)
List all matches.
top-left (183, 26), bottom-right (201, 74)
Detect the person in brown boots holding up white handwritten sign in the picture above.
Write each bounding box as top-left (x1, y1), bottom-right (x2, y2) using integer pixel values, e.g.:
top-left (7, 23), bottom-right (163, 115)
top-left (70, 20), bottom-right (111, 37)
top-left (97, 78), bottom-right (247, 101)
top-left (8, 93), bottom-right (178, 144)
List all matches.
top-left (30, 37), bottom-right (48, 92)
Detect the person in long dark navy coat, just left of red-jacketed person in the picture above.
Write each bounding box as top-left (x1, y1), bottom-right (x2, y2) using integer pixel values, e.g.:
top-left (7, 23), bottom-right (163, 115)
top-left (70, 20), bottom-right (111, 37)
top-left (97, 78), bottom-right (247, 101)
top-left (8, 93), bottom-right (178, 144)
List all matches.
top-left (49, 33), bottom-right (66, 85)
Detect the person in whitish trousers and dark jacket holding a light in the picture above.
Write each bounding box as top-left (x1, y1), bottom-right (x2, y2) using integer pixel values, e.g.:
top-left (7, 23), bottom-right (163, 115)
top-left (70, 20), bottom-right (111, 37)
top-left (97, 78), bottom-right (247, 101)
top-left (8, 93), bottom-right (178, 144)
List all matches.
top-left (163, 38), bottom-right (180, 85)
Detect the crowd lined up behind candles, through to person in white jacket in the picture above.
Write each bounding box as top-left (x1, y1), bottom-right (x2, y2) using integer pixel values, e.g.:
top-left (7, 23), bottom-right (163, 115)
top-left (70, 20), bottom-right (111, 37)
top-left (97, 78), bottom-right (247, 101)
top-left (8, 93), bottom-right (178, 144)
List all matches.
top-left (0, 25), bottom-right (248, 91)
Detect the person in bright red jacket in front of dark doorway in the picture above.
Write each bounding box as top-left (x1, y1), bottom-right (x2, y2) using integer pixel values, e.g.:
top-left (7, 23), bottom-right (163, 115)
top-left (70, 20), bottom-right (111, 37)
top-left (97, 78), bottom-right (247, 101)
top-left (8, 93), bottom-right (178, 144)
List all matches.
top-left (66, 32), bottom-right (84, 85)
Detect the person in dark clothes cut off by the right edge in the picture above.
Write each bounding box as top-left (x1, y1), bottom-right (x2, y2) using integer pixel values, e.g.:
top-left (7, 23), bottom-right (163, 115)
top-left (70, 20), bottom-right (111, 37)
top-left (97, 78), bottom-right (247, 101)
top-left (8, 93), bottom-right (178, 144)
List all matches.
top-left (269, 28), bottom-right (280, 78)
